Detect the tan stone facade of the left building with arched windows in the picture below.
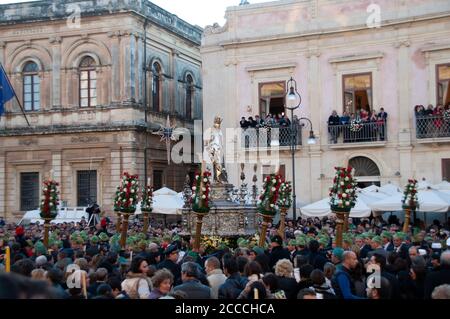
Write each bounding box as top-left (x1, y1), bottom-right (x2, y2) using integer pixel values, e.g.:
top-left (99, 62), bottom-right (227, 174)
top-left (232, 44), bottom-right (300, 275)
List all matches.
top-left (0, 0), bottom-right (202, 218)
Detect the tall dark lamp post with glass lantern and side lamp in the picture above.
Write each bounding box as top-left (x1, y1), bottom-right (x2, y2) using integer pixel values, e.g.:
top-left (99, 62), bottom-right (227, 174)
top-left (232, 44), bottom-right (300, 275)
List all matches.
top-left (286, 77), bottom-right (316, 221)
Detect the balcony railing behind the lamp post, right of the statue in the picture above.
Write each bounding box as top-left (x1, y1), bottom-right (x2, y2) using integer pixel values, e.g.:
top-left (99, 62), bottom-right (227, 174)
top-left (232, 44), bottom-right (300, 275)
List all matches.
top-left (240, 125), bottom-right (302, 149)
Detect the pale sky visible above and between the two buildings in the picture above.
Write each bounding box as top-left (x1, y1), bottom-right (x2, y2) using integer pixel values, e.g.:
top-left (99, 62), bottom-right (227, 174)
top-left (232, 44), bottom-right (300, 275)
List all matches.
top-left (0, 0), bottom-right (273, 28)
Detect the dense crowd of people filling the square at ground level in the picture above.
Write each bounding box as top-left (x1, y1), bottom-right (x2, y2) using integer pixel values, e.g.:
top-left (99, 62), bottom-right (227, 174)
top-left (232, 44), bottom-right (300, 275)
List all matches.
top-left (0, 217), bottom-right (450, 299)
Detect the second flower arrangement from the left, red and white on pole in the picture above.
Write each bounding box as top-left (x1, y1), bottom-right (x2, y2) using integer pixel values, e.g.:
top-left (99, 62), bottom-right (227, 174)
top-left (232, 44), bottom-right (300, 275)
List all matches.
top-left (114, 172), bottom-right (139, 214)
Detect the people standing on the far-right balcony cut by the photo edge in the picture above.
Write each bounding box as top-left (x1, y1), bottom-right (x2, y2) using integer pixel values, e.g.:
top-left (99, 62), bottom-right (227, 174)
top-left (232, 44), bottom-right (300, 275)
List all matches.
top-left (414, 103), bottom-right (450, 138)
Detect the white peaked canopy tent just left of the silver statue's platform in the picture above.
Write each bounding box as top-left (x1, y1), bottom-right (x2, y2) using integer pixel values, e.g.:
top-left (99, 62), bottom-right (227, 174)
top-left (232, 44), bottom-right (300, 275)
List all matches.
top-left (136, 187), bottom-right (184, 215)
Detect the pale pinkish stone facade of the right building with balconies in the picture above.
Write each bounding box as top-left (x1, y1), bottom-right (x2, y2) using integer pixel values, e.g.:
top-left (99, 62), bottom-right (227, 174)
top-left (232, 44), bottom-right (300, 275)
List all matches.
top-left (201, 0), bottom-right (450, 215)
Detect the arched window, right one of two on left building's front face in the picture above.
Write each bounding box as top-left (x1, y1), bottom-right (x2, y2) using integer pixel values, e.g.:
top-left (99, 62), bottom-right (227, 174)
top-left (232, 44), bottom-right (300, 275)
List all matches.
top-left (80, 56), bottom-right (97, 107)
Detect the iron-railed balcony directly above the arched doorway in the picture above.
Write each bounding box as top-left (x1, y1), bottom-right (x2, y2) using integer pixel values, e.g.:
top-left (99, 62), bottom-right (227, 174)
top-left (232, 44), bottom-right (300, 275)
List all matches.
top-left (328, 120), bottom-right (387, 148)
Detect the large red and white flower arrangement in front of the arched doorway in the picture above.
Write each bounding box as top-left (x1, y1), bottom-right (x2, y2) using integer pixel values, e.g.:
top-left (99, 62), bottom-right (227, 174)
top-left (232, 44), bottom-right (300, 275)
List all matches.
top-left (329, 166), bottom-right (357, 212)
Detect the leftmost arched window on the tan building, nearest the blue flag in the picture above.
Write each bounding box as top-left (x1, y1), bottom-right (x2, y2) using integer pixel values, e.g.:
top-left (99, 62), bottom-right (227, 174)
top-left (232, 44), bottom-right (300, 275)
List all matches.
top-left (23, 62), bottom-right (41, 111)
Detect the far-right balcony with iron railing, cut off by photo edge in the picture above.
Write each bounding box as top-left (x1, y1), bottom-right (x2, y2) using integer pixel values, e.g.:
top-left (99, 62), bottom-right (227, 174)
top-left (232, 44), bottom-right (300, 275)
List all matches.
top-left (416, 115), bottom-right (450, 143)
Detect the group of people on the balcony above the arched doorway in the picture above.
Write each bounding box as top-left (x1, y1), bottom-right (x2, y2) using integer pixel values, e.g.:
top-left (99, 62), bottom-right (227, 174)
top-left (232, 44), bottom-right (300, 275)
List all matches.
top-left (328, 108), bottom-right (388, 144)
